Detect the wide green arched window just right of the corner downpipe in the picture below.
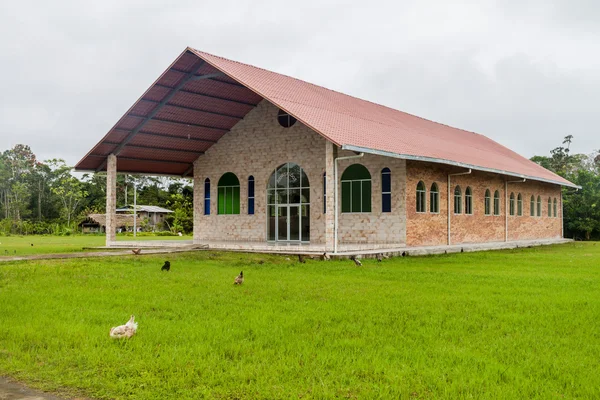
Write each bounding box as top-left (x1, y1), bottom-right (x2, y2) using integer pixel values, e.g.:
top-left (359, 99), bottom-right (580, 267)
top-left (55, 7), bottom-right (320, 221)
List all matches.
top-left (342, 164), bottom-right (371, 213)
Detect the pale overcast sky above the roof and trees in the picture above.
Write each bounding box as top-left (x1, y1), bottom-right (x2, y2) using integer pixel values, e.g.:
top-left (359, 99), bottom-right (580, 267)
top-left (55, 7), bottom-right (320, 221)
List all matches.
top-left (0, 0), bottom-right (600, 165)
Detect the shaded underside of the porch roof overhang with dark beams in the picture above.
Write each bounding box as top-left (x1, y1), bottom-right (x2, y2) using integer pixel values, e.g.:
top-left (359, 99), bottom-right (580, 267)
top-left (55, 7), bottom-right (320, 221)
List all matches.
top-left (75, 48), bottom-right (262, 177)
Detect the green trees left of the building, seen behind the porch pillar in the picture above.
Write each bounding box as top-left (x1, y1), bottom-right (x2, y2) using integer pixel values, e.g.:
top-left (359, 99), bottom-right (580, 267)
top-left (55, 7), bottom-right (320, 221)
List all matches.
top-left (0, 144), bottom-right (193, 236)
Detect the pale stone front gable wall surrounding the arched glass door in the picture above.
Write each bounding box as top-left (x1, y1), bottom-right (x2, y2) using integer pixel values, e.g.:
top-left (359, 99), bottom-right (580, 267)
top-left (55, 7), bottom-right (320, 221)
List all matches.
top-left (194, 100), bottom-right (331, 243)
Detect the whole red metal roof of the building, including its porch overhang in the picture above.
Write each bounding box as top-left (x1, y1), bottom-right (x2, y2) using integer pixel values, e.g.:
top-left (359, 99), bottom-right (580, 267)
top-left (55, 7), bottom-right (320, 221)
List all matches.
top-left (76, 48), bottom-right (575, 187)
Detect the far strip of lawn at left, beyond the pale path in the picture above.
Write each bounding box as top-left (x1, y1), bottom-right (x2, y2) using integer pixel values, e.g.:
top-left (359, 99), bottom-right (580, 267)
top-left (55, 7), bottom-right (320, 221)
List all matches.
top-left (0, 235), bottom-right (192, 257)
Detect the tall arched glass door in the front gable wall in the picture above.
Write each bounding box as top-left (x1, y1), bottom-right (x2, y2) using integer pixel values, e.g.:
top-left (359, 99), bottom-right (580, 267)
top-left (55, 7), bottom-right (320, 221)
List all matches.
top-left (267, 163), bottom-right (310, 242)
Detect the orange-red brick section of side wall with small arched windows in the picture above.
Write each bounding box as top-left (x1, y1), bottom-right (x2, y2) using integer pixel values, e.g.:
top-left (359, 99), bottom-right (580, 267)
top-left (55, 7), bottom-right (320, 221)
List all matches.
top-left (406, 161), bottom-right (562, 246)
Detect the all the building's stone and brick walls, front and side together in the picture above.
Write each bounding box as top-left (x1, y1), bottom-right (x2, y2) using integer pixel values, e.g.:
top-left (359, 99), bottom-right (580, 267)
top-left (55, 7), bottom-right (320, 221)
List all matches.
top-left (194, 101), bottom-right (562, 251)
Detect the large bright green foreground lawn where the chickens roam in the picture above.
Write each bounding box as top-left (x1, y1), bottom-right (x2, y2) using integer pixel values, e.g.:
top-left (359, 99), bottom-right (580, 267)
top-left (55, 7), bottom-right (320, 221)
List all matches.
top-left (0, 243), bottom-right (600, 399)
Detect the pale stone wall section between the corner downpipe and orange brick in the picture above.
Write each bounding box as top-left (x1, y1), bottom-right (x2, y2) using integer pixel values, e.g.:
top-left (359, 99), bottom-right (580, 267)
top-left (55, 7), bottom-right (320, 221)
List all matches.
top-left (338, 151), bottom-right (406, 246)
